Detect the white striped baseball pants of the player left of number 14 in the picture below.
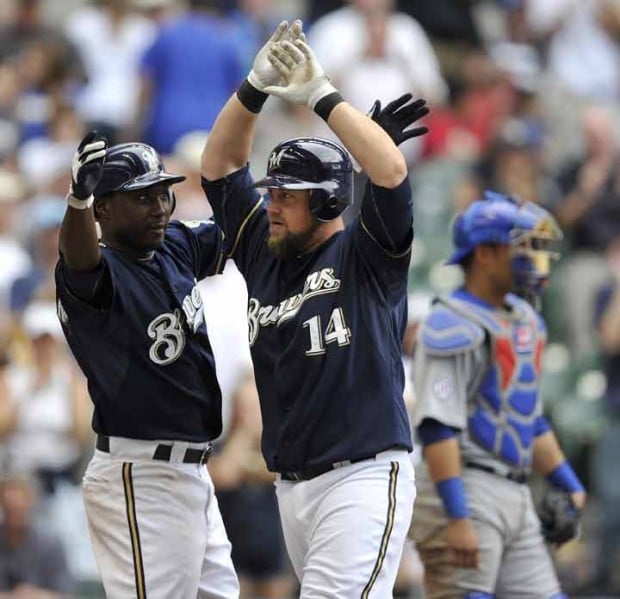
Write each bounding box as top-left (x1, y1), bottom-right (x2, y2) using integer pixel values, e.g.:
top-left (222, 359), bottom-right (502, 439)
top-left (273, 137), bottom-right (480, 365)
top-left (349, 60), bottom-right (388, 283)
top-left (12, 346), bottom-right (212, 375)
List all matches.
top-left (83, 437), bottom-right (239, 599)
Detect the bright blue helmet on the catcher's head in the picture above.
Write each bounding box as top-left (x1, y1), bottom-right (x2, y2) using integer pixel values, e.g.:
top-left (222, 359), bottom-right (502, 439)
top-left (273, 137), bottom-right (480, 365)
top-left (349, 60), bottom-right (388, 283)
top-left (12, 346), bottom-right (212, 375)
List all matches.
top-left (446, 191), bottom-right (519, 264)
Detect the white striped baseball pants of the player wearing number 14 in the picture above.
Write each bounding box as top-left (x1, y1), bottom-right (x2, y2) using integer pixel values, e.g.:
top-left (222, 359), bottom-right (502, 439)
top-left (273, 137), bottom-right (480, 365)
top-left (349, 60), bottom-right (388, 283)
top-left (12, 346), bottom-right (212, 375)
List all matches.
top-left (275, 450), bottom-right (416, 599)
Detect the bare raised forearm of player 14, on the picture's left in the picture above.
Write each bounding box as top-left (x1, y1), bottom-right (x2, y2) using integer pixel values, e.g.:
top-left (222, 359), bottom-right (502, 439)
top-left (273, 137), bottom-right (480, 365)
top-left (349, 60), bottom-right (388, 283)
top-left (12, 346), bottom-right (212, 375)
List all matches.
top-left (202, 94), bottom-right (258, 181)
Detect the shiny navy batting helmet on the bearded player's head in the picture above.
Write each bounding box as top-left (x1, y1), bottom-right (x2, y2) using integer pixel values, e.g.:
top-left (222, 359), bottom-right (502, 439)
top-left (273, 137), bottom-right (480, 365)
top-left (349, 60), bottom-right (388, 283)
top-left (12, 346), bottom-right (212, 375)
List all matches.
top-left (254, 137), bottom-right (353, 222)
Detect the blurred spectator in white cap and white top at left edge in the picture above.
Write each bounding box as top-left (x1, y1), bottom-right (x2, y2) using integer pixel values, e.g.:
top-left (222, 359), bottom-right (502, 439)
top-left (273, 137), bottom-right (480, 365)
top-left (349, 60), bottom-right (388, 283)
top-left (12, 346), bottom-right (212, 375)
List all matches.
top-left (0, 301), bottom-right (97, 579)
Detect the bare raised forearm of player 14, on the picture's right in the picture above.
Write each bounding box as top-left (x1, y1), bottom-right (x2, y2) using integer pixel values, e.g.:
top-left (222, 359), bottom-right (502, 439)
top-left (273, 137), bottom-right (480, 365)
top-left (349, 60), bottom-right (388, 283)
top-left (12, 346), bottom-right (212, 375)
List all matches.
top-left (327, 102), bottom-right (407, 189)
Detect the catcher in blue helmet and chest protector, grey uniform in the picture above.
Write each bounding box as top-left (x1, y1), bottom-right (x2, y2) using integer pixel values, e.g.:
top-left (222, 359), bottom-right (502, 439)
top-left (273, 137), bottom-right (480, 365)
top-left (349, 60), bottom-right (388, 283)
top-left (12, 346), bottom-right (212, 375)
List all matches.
top-left (412, 192), bottom-right (585, 599)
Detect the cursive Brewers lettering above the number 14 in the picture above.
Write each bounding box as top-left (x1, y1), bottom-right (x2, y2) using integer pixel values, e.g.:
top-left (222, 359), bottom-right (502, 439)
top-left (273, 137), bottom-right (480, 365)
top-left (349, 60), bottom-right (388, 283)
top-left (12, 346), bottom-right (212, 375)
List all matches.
top-left (248, 268), bottom-right (340, 346)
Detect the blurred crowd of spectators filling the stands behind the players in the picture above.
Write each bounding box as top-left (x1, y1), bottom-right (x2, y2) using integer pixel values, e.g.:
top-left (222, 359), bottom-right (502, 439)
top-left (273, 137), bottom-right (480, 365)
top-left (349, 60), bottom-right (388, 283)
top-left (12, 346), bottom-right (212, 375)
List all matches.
top-left (0, 0), bottom-right (620, 599)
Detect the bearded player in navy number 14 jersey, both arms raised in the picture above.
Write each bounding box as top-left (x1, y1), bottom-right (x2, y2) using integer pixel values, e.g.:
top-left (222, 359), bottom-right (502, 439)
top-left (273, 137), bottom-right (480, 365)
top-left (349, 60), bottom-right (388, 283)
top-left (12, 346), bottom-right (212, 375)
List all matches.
top-left (202, 21), bottom-right (427, 599)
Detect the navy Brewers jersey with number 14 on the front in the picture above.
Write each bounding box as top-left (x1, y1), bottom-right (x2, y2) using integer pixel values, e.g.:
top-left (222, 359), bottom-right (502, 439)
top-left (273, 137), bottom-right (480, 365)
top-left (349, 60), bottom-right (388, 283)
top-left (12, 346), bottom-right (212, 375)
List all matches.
top-left (203, 166), bottom-right (412, 472)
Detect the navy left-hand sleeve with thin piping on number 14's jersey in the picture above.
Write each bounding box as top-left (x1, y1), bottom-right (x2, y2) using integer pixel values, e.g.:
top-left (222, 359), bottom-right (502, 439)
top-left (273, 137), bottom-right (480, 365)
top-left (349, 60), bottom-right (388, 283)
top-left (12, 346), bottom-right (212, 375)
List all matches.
top-left (202, 165), bottom-right (269, 275)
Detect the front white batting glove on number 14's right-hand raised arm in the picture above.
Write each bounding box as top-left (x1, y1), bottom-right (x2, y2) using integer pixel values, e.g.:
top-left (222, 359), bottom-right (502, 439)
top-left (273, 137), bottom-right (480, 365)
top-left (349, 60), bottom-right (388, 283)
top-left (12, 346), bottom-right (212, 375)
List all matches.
top-left (263, 39), bottom-right (338, 110)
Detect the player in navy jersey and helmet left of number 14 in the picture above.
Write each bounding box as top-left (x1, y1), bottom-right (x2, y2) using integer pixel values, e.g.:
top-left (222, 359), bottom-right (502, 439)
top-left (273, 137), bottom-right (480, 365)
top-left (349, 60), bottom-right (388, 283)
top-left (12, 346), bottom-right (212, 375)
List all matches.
top-left (56, 133), bottom-right (239, 599)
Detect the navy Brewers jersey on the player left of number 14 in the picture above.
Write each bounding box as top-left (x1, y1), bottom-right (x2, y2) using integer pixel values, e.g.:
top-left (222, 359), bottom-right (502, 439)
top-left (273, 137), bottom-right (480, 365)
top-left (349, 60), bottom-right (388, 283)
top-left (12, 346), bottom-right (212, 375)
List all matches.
top-left (56, 221), bottom-right (224, 442)
